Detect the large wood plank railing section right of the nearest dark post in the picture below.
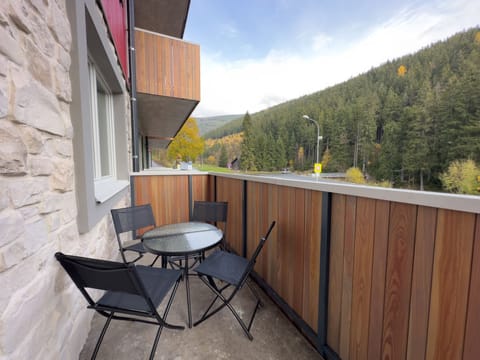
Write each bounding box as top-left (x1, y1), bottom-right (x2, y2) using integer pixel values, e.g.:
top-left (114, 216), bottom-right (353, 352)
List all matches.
top-left (327, 194), bottom-right (480, 359)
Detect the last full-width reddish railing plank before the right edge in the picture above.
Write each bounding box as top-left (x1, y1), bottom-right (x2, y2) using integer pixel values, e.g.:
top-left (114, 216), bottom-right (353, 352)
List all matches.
top-left (427, 210), bottom-right (474, 359)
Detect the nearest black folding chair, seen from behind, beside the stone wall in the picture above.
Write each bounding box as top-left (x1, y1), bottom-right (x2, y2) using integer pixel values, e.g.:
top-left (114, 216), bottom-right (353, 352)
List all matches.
top-left (55, 252), bottom-right (184, 359)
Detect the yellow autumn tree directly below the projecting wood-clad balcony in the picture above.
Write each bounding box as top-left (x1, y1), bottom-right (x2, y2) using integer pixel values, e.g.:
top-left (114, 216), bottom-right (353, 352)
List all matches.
top-left (167, 118), bottom-right (205, 161)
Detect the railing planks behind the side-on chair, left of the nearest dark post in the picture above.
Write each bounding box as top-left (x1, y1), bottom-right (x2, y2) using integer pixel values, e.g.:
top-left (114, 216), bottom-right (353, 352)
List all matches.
top-left (217, 178), bottom-right (322, 331)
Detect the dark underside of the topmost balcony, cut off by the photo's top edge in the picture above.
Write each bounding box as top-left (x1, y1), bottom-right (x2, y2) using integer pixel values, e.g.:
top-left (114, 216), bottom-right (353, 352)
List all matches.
top-left (135, 0), bottom-right (190, 38)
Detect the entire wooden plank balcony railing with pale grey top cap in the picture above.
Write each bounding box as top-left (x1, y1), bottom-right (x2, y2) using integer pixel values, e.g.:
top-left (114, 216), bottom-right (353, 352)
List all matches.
top-left (133, 170), bottom-right (480, 359)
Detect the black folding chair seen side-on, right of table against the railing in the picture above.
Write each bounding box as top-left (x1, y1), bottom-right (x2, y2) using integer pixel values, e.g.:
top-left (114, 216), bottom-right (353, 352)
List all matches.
top-left (193, 221), bottom-right (275, 340)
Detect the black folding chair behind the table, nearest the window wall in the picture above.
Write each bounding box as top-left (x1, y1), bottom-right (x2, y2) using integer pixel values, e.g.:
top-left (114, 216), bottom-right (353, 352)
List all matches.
top-left (111, 204), bottom-right (158, 266)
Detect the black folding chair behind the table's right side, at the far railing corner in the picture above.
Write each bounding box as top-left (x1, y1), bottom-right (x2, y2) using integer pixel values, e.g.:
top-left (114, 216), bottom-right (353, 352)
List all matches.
top-left (168, 200), bottom-right (228, 268)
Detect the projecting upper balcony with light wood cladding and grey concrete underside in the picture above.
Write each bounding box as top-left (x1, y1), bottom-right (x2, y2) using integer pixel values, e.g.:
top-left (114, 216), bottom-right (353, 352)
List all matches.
top-left (135, 28), bottom-right (200, 147)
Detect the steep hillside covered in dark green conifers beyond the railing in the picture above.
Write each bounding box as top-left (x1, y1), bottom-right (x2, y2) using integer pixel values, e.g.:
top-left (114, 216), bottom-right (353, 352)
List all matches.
top-left (208, 28), bottom-right (480, 189)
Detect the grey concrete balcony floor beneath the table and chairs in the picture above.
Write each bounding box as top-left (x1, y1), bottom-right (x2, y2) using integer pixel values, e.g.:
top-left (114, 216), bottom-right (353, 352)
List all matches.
top-left (79, 255), bottom-right (322, 360)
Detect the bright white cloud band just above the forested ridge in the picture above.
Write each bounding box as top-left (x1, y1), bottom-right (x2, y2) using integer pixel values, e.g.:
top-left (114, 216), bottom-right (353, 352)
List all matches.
top-left (194, 0), bottom-right (480, 116)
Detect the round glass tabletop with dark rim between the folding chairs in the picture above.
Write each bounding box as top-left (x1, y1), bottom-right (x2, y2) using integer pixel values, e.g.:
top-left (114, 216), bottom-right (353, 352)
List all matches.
top-left (142, 222), bottom-right (223, 255)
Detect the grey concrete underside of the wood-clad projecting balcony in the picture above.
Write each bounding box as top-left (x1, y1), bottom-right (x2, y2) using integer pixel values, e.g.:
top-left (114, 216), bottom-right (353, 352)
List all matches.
top-left (137, 93), bottom-right (198, 148)
